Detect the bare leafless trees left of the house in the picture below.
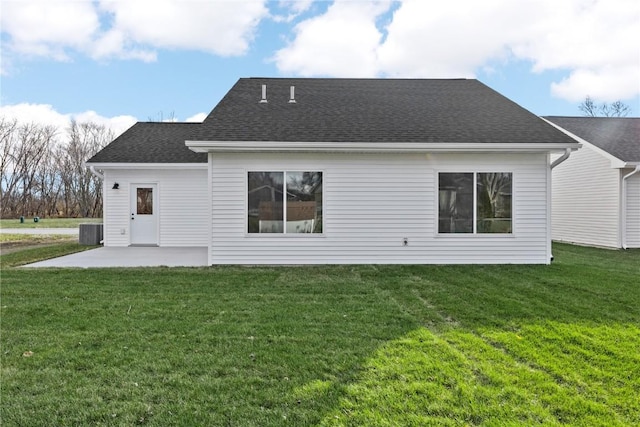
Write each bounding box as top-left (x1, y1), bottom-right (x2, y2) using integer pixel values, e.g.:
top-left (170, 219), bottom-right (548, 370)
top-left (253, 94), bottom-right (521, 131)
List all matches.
top-left (0, 117), bottom-right (114, 218)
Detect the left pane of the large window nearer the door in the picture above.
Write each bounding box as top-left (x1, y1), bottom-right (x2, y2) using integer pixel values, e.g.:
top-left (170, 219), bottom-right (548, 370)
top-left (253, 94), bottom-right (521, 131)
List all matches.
top-left (247, 172), bottom-right (284, 233)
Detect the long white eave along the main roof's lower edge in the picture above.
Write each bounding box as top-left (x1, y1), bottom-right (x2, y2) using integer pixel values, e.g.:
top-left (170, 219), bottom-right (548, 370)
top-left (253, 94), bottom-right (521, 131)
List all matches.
top-left (185, 141), bottom-right (580, 153)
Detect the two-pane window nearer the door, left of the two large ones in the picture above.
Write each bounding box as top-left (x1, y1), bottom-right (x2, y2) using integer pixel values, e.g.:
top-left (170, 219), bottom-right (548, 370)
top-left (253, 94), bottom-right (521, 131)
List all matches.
top-left (247, 172), bottom-right (322, 234)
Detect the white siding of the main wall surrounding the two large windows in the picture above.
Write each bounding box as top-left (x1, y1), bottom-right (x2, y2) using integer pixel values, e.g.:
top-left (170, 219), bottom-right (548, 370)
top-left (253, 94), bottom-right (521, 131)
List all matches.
top-left (209, 153), bottom-right (549, 264)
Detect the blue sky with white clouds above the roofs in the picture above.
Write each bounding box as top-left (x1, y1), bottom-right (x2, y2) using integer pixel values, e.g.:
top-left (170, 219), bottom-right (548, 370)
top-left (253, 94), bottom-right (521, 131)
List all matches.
top-left (0, 0), bottom-right (640, 137)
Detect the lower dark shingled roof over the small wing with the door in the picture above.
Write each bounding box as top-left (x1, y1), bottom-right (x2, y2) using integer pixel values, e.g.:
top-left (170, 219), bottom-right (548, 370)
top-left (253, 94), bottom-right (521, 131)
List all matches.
top-left (87, 122), bottom-right (207, 163)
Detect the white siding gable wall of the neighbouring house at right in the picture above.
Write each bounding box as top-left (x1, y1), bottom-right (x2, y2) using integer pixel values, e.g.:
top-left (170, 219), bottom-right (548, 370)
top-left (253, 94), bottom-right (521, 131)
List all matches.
top-left (551, 146), bottom-right (620, 247)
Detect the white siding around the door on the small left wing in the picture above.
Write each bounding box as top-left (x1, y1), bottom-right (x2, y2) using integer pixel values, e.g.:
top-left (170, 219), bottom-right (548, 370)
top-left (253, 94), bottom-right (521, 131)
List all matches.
top-left (103, 168), bottom-right (209, 246)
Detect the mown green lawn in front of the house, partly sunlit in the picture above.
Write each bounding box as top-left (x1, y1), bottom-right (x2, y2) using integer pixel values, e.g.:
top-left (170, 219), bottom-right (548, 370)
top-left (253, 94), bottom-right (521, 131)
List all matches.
top-left (0, 245), bottom-right (640, 426)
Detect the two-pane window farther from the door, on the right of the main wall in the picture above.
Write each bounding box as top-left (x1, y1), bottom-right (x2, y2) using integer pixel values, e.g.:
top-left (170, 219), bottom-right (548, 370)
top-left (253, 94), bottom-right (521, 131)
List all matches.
top-left (438, 172), bottom-right (513, 234)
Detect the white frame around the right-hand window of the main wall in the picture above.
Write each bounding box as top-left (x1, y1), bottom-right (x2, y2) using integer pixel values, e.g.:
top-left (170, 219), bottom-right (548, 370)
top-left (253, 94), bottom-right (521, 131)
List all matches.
top-left (434, 171), bottom-right (516, 239)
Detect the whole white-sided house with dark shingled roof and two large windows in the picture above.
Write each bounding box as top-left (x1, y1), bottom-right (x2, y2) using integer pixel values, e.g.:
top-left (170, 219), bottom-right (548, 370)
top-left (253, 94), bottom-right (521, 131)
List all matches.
top-left (87, 78), bottom-right (579, 265)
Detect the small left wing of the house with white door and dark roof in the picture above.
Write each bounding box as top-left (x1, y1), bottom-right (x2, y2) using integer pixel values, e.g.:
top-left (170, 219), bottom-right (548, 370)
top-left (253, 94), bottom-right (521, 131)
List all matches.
top-left (87, 123), bottom-right (210, 247)
